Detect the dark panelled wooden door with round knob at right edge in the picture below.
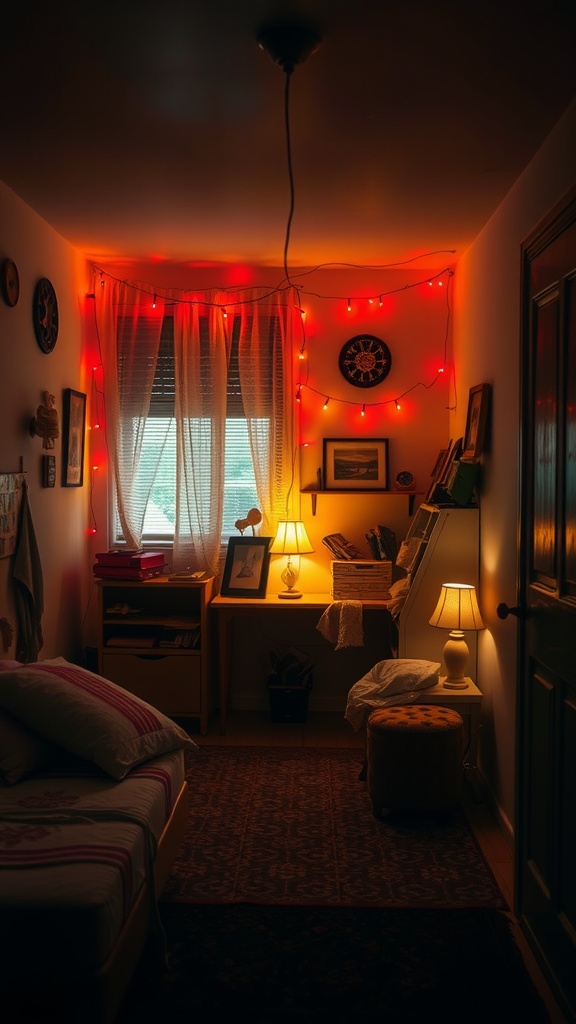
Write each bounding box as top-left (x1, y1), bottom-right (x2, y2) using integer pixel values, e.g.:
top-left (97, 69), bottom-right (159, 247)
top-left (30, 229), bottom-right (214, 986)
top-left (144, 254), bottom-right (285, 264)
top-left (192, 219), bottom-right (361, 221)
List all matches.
top-left (515, 193), bottom-right (576, 1020)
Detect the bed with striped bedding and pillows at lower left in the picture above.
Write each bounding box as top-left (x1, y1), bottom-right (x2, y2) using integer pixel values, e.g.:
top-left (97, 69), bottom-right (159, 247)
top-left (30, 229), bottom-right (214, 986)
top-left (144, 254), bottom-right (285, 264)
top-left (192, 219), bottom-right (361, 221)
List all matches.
top-left (0, 658), bottom-right (196, 1024)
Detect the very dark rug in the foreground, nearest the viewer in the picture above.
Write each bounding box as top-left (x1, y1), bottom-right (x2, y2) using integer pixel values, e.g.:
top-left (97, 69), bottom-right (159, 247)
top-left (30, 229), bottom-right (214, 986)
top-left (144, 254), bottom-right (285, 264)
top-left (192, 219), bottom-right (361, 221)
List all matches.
top-left (115, 903), bottom-right (549, 1024)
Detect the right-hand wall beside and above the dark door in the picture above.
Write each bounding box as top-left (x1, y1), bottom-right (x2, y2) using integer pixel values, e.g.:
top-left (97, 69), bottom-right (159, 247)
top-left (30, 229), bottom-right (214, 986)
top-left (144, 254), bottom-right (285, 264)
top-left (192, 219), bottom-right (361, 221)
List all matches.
top-left (451, 94), bottom-right (576, 826)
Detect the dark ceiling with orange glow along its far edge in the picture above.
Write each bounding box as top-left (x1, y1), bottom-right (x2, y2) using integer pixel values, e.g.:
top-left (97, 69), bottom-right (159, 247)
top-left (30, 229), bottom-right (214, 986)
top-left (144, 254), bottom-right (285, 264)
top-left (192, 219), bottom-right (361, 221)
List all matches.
top-left (0, 0), bottom-right (576, 268)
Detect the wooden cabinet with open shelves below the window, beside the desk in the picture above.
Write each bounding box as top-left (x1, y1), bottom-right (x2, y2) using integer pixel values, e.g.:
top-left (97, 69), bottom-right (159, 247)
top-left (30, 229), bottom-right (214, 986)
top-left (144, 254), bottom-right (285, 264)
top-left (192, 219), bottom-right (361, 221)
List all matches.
top-left (97, 577), bottom-right (213, 735)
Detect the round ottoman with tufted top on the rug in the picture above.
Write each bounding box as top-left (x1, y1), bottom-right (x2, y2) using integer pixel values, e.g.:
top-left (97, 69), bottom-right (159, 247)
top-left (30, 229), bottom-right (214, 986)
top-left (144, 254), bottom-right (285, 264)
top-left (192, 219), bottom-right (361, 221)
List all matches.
top-left (366, 703), bottom-right (464, 817)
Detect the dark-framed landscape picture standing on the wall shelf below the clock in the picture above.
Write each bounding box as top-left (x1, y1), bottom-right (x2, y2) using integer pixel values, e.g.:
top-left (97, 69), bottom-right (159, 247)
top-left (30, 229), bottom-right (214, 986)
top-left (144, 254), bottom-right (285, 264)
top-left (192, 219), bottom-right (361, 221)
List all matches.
top-left (324, 437), bottom-right (389, 490)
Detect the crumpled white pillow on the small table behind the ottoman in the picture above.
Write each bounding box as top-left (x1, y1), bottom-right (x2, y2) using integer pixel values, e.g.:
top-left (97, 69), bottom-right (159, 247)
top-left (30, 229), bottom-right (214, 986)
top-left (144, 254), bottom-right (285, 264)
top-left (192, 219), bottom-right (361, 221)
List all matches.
top-left (342, 657), bottom-right (441, 730)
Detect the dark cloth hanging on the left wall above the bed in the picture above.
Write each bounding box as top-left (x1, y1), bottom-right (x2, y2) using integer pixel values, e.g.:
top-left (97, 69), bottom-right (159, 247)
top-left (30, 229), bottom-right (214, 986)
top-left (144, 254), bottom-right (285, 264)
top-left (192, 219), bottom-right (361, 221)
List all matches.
top-left (12, 483), bottom-right (44, 663)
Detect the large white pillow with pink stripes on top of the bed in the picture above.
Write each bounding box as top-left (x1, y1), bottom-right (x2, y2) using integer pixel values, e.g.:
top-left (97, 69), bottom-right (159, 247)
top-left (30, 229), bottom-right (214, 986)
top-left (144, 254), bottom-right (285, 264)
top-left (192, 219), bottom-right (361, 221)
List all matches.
top-left (0, 658), bottom-right (198, 779)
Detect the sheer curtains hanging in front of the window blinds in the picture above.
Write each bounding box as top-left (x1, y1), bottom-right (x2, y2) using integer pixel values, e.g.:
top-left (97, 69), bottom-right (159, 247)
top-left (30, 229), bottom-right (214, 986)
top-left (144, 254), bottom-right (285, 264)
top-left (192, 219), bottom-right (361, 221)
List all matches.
top-left (94, 274), bottom-right (300, 575)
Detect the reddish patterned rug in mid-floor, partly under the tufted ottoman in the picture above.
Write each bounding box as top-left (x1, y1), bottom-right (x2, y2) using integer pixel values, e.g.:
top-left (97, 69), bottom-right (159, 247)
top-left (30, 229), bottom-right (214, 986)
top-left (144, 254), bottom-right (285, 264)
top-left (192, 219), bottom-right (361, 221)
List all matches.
top-left (162, 745), bottom-right (506, 909)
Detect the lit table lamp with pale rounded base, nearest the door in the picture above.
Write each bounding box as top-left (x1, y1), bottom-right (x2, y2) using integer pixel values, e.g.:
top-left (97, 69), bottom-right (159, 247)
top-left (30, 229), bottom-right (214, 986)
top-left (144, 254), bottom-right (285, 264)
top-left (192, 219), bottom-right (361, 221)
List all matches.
top-left (429, 583), bottom-right (484, 690)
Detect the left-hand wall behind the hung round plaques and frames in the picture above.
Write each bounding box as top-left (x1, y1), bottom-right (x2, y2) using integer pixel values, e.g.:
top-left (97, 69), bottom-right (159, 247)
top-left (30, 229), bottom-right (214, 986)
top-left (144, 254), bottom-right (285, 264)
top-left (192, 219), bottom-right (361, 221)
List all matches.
top-left (0, 182), bottom-right (89, 657)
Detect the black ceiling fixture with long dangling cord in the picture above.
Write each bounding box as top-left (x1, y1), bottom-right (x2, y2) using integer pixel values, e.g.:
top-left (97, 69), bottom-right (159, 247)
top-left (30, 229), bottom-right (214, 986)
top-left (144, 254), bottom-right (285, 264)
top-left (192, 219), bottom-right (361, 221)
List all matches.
top-left (256, 22), bottom-right (320, 283)
